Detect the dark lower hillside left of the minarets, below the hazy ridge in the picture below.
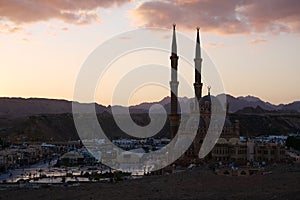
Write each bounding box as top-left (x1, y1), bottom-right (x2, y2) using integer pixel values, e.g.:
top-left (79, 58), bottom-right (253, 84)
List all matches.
top-left (0, 113), bottom-right (168, 142)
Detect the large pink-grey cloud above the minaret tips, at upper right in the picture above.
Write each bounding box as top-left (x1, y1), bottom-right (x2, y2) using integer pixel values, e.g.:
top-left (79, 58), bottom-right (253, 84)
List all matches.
top-left (131, 0), bottom-right (300, 34)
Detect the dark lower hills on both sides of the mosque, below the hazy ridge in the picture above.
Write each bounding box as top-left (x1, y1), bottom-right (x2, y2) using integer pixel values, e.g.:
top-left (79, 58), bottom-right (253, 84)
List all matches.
top-left (0, 107), bottom-right (300, 142)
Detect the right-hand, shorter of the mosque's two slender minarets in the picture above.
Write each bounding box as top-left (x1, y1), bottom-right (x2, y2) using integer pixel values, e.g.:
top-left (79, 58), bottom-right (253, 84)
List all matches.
top-left (194, 27), bottom-right (203, 106)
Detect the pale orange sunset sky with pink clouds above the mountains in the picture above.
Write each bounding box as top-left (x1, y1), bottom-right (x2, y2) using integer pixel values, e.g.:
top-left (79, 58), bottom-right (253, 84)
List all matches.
top-left (0, 0), bottom-right (300, 105)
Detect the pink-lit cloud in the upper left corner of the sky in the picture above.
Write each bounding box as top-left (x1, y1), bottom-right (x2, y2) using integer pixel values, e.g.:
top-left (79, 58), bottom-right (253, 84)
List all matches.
top-left (0, 0), bottom-right (130, 32)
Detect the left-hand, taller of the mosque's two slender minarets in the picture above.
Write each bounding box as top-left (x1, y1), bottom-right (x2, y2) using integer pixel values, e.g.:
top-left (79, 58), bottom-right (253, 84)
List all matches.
top-left (169, 24), bottom-right (179, 139)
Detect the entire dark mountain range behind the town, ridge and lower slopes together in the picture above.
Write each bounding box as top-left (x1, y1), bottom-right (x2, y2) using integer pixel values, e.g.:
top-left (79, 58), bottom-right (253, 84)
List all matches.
top-left (0, 94), bottom-right (300, 141)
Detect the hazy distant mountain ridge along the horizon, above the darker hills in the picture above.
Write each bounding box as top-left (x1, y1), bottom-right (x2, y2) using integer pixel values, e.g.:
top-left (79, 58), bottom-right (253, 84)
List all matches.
top-left (0, 94), bottom-right (300, 119)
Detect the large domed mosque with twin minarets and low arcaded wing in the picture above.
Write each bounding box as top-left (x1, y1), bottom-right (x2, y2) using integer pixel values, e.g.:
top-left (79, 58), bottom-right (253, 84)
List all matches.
top-left (169, 24), bottom-right (286, 166)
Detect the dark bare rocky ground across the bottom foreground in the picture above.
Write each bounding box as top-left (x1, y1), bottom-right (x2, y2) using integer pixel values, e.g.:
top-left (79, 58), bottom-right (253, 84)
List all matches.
top-left (0, 165), bottom-right (300, 200)
